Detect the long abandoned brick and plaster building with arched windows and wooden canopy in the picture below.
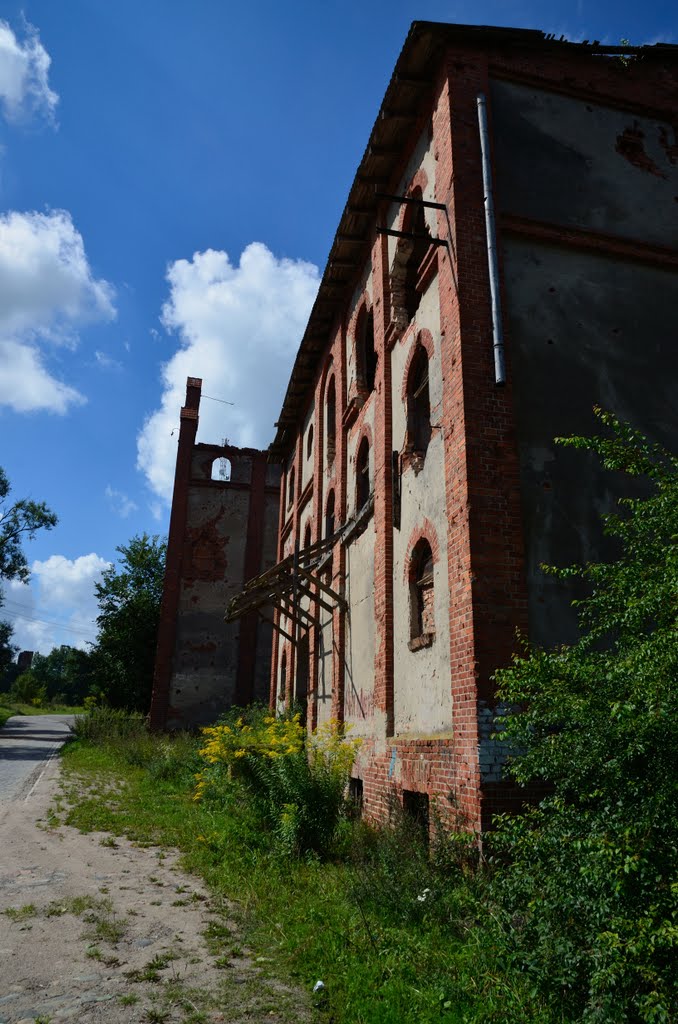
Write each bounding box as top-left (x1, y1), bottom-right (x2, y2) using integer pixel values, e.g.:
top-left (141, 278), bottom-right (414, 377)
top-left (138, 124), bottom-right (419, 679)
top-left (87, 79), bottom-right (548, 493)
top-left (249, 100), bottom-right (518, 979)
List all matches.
top-left (155, 23), bottom-right (678, 828)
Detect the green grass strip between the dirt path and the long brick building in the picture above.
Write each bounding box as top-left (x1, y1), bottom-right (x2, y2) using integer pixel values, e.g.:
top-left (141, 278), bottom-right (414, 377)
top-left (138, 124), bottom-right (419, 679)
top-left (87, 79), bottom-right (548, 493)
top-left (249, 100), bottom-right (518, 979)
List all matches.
top-left (58, 733), bottom-right (560, 1024)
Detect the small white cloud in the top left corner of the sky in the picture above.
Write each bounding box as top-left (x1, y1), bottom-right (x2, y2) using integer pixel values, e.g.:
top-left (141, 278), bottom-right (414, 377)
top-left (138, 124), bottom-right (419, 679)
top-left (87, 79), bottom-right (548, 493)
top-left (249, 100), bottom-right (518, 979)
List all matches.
top-left (0, 20), bottom-right (58, 122)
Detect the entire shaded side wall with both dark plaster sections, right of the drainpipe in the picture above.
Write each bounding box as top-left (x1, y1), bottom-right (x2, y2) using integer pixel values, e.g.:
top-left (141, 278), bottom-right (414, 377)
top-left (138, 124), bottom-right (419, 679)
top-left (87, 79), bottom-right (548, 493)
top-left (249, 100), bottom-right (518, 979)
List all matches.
top-left (492, 75), bottom-right (678, 646)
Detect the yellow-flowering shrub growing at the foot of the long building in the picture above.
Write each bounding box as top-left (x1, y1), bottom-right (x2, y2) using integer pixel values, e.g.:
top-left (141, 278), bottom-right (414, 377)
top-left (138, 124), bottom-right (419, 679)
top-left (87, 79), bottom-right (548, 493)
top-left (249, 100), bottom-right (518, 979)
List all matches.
top-left (196, 714), bottom-right (358, 855)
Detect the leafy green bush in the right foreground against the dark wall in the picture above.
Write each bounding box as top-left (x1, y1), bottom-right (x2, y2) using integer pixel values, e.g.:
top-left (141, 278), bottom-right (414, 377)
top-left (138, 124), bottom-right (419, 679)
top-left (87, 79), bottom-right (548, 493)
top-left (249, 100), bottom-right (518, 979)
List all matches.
top-left (492, 411), bottom-right (678, 1024)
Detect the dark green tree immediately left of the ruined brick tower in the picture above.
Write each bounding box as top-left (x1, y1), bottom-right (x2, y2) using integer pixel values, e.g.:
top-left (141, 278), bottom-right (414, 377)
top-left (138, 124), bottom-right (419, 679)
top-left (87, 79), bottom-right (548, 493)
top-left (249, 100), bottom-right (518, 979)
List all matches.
top-left (92, 534), bottom-right (167, 712)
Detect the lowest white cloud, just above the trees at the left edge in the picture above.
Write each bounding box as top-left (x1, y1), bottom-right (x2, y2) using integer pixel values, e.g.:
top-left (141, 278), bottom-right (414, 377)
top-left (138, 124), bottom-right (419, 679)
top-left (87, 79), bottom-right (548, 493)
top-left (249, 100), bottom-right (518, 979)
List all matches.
top-left (0, 552), bottom-right (111, 654)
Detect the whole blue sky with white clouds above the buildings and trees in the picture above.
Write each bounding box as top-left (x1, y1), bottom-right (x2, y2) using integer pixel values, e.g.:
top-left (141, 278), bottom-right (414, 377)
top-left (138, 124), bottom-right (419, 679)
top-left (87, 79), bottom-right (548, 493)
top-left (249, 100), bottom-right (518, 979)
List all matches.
top-left (0, 0), bottom-right (678, 653)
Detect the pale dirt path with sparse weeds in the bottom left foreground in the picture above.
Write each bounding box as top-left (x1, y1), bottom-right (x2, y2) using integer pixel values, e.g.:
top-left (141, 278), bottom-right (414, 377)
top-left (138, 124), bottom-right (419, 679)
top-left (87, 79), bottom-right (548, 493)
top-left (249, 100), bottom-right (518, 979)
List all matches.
top-left (0, 762), bottom-right (310, 1024)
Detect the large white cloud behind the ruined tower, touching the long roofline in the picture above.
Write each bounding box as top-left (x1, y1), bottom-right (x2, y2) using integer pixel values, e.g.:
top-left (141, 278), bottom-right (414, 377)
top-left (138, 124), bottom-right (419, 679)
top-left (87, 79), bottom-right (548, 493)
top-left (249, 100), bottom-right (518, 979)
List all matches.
top-left (137, 242), bottom-right (320, 502)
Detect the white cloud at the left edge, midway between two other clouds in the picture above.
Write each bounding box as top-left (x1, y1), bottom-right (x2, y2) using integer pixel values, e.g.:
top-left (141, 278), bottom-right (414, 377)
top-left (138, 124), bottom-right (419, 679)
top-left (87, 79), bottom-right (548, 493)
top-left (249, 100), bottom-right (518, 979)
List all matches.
top-left (0, 210), bottom-right (115, 413)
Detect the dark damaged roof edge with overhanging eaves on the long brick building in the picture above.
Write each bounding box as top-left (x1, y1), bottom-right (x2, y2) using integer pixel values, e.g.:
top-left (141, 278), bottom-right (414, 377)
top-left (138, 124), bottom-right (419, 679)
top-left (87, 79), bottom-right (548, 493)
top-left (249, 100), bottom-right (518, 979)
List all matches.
top-left (268, 22), bottom-right (678, 462)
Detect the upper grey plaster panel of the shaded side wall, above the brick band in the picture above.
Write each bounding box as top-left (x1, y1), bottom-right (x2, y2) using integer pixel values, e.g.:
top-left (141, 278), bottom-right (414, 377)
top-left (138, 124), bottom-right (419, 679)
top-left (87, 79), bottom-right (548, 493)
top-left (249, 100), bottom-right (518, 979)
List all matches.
top-left (491, 81), bottom-right (678, 247)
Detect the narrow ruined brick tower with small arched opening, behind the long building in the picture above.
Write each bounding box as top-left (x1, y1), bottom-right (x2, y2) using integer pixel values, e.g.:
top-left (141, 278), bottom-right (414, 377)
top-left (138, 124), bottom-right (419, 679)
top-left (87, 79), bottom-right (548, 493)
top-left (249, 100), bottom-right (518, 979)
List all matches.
top-left (151, 377), bottom-right (280, 729)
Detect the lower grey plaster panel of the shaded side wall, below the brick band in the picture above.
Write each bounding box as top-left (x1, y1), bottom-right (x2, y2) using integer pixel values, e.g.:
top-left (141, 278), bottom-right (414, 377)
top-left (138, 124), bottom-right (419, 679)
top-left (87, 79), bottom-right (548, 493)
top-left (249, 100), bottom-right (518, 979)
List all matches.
top-left (504, 240), bottom-right (678, 644)
